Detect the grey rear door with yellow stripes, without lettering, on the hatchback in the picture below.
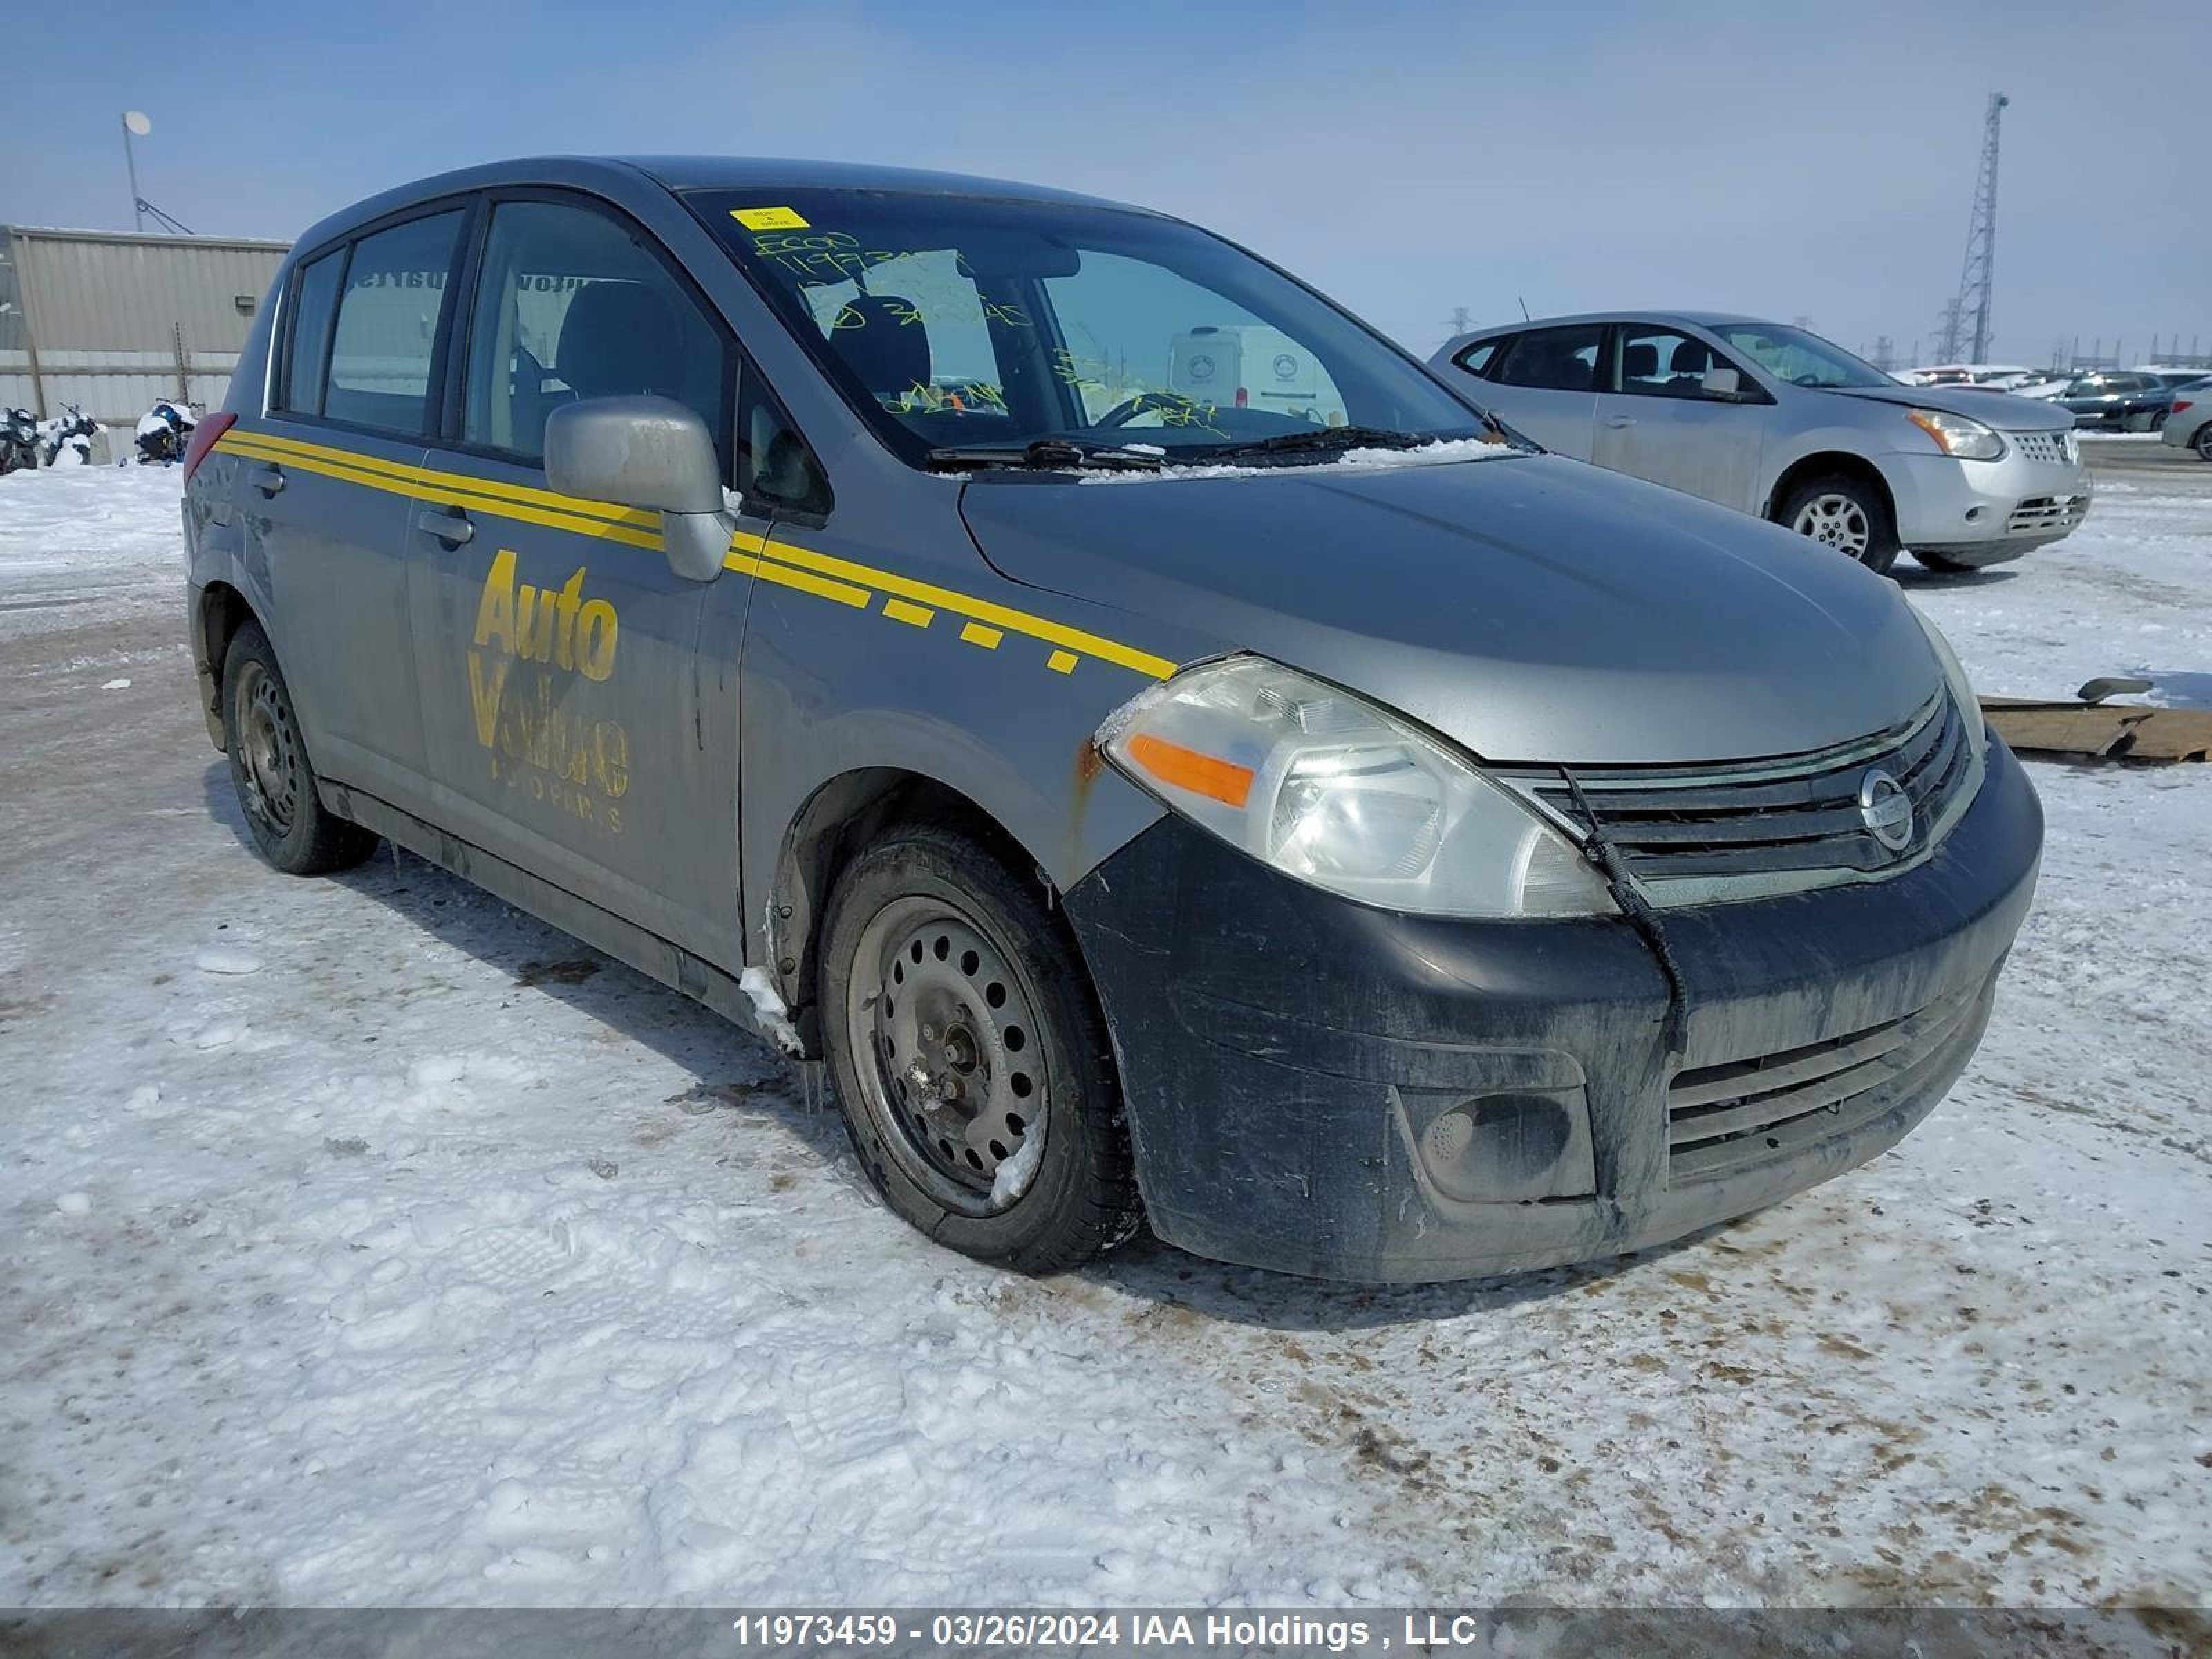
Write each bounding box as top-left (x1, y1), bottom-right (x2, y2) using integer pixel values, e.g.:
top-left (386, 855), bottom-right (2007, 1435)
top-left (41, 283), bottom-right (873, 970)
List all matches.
top-left (238, 206), bottom-right (467, 805)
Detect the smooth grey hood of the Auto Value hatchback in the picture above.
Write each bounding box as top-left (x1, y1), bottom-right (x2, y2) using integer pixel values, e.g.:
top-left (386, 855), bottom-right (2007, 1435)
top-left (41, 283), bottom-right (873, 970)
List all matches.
top-left (960, 453), bottom-right (1942, 765)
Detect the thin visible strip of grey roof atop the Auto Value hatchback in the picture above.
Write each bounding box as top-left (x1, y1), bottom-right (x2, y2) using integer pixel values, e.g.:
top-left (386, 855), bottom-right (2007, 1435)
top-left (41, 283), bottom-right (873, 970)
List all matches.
top-left (294, 155), bottom-right (1146, 252)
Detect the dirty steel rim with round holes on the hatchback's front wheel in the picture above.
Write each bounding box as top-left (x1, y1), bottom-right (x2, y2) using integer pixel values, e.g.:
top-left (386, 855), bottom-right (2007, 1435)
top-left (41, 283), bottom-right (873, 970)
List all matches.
top-left (845, 896), bottom-right (1053, 1215)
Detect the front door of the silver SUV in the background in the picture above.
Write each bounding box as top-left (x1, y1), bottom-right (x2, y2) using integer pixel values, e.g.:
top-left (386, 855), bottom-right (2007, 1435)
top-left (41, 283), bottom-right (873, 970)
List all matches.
top-left (1591, 323), bottom-right (1772, 513)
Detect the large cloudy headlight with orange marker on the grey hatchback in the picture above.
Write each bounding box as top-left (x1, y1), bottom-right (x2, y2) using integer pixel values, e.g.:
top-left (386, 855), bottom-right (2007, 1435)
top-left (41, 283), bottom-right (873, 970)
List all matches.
top-left (1097, 657), bottom-right (1615, 918)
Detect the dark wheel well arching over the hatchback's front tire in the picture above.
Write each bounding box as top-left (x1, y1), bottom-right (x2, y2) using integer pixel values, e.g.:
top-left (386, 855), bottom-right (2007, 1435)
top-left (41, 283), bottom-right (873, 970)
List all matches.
top-left (767, 767), bottom-right (1044, 1055)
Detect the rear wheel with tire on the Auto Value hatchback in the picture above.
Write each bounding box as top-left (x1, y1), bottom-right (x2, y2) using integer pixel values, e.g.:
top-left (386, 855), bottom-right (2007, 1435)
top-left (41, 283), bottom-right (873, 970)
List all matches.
top-left (223, 621), bottom-right (376, 876)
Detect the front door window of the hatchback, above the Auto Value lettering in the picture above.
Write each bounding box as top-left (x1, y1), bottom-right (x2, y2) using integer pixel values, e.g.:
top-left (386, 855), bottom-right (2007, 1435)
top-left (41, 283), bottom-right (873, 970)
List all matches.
top-left (460, 201), bottom-right (730, 473)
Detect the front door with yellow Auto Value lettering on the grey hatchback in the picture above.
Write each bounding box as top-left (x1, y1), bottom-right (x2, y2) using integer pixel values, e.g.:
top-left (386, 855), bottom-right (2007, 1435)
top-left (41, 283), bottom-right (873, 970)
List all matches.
top-left (407, 192), bottom-right (770, 960)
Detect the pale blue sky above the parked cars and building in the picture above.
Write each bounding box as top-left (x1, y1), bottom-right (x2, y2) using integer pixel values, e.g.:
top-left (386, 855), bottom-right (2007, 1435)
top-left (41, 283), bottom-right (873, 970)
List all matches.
top-left (17, 0), bottom-right (2212, 363)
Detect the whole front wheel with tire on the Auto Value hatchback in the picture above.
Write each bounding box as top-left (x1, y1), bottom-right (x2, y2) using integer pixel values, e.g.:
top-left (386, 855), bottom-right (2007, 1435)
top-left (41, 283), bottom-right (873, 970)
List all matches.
top-left (818, 825), bottom-right (1143, 1274)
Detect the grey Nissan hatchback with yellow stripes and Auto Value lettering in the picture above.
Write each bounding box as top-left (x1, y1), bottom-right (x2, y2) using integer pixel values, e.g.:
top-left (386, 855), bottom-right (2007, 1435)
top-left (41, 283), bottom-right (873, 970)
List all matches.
top-left (184, 159), bottom-right (2042, 1281)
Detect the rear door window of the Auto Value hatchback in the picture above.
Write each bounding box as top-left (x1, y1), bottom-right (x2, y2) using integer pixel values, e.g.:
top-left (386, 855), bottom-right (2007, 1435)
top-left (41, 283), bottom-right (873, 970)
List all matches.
top-left (323, 210), bottom-right (462, 438)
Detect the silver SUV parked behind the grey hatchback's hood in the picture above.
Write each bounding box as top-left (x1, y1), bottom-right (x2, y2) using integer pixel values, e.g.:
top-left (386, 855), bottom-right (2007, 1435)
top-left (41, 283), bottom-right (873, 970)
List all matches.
top-left (1431, 312), bottom-right (2090, 571)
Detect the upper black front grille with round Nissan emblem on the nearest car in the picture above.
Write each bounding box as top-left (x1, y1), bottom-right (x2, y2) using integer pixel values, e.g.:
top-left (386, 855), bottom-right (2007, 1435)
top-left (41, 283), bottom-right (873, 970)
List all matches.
top-left (1511, 693), bottom-right (1978, 905)
